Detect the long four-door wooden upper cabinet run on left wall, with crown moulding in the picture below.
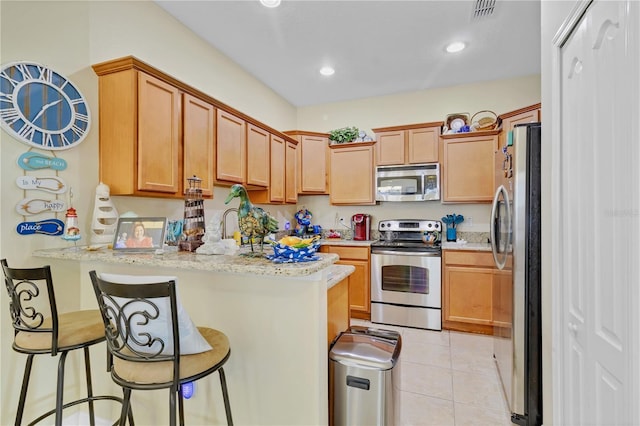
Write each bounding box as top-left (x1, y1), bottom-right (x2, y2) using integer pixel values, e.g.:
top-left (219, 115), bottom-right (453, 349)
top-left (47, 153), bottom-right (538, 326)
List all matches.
top-left (93, 56), bottom-right (288, 198)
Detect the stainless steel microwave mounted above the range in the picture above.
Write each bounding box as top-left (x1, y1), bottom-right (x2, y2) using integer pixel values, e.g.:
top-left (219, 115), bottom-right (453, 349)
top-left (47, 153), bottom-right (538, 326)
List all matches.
top-left (376, 163), bottom-right (440, 201)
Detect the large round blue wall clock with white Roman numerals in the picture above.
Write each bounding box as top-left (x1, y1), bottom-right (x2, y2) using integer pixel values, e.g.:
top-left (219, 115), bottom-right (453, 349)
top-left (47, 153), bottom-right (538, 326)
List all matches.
top-left (0, 62), bottom-right (91, 150)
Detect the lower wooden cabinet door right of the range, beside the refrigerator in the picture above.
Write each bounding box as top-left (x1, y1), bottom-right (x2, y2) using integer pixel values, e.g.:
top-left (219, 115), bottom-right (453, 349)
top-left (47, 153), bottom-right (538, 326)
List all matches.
top-left (443, 266), bottom-right (493, 325)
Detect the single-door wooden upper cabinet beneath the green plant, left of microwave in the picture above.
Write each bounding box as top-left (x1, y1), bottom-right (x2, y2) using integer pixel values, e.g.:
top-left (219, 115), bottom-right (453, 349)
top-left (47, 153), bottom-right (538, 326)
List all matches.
top-left (329, 142), bottom-right (376, 204)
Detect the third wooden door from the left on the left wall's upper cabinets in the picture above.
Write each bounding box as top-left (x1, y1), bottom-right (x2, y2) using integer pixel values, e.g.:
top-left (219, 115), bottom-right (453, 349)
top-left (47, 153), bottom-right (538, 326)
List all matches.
top-left (216, 109), bottom-right (247, 183)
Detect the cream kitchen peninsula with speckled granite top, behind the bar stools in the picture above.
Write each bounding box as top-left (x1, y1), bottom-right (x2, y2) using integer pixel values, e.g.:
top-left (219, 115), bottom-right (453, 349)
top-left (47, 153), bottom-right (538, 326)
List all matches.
top-left (33, 248), bottom-right (353, 425)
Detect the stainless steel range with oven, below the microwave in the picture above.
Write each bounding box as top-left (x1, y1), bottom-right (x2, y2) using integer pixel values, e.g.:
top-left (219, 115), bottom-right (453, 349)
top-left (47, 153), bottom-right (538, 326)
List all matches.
top-left (371, 219), bottom-right (442, 330)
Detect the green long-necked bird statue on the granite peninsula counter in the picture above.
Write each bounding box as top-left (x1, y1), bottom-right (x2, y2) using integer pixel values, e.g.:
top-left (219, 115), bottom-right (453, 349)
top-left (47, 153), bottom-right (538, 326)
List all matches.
top-left (224, 184), bottom-right (278, 251)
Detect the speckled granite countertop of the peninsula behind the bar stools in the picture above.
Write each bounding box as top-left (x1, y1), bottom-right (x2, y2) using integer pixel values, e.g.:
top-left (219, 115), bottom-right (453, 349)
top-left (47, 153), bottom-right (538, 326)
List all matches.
top-left (33, 247), bottom-right (340, 277)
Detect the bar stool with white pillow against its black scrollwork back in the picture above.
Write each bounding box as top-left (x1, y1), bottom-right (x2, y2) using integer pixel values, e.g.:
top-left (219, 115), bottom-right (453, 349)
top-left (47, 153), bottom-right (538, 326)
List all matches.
top-left (89, 271), bottom-right (233, 426)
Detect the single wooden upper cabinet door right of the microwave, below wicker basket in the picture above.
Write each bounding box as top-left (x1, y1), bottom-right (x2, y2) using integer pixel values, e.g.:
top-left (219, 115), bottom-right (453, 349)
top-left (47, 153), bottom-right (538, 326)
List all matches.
top-left (442, 135), bottom-right (497, 203)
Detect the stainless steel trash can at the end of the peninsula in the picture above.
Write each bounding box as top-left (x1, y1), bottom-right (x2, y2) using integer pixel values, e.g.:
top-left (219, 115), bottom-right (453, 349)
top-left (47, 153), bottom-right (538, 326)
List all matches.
top-left (329, 326), bottom-right (402, 426)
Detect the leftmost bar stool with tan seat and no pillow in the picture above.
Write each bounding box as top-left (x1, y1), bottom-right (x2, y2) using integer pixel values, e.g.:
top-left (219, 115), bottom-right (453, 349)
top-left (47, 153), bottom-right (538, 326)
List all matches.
top-left (0, 259), bottom-right (123, 426)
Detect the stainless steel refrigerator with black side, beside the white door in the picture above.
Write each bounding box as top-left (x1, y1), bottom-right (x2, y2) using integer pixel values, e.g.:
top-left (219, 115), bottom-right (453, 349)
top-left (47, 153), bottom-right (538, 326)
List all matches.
top-left (490, 123), bottom-right (542, 426)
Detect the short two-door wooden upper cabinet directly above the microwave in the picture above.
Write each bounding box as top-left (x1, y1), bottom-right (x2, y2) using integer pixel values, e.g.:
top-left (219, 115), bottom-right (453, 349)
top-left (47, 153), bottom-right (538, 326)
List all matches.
top-left (372, 122), bottom-right (443, 166)
